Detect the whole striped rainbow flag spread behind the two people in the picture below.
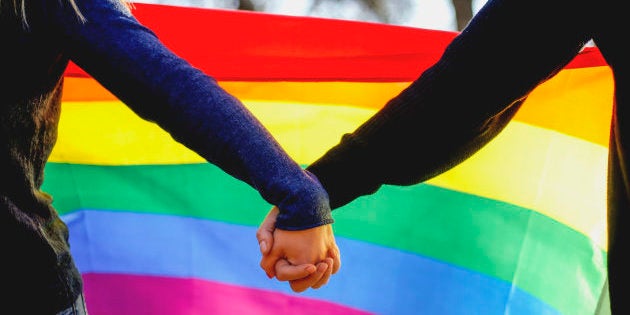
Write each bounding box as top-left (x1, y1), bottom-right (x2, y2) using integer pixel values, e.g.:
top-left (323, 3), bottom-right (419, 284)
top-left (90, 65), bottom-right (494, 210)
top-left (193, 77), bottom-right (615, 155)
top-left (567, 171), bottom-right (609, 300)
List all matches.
top-left (43, 4), bottom-right (613, 315)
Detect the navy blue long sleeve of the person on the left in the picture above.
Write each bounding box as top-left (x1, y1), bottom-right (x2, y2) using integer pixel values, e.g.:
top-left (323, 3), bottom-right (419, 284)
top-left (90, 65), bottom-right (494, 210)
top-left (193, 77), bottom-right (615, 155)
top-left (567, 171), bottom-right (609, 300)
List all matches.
top-left (42, 0), bottom-right (333, 230)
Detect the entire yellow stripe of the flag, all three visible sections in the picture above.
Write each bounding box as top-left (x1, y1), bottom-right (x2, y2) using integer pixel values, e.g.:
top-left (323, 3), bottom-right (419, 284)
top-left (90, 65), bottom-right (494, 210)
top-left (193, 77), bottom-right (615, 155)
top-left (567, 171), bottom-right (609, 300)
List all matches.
top-left (51, 101), bottom-right (607, 249)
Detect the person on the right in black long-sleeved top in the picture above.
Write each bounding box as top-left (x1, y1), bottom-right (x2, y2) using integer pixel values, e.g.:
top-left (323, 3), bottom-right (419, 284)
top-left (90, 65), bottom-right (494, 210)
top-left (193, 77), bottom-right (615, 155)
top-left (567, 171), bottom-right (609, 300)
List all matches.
top-left (259, 0), bottom-right (630, 314)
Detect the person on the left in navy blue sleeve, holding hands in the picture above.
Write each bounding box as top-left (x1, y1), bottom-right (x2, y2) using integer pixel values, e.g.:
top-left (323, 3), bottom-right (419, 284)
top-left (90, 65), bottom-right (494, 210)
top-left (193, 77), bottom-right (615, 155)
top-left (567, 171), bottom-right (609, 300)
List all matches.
top-left (0, 0), bottom-right (340, 314)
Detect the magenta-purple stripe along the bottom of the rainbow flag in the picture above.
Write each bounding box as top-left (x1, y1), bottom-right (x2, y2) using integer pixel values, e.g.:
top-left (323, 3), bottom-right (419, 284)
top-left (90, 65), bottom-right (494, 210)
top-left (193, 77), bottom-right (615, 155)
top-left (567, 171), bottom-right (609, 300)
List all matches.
top-left (83, 274), bottom-right (370, 315)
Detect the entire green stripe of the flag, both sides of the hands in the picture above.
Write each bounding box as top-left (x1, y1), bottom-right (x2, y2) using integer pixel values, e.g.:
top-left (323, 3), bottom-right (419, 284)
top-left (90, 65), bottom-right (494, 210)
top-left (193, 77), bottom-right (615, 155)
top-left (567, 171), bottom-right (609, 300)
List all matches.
top-left (43, 163), bottom-right (606, 314)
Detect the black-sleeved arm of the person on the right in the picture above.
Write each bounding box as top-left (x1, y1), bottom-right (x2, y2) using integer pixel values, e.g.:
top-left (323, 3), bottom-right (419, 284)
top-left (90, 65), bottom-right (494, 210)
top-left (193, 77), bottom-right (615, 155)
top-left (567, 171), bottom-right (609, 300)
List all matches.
top-left (308, 0), bottom-right (590, 209)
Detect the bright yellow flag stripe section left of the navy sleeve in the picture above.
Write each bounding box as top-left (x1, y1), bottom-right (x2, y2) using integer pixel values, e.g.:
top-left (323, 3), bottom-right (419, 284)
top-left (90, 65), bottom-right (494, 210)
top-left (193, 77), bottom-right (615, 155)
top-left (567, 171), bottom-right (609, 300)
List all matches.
top-left (49, 101), bottom-right (202, 165)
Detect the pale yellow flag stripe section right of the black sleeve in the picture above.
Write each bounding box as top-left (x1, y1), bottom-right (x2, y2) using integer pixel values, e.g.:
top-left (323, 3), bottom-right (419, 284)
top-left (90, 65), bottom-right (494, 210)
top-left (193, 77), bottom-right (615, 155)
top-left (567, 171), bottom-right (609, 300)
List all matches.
top-left (428, 122), bottom-right (608, 250)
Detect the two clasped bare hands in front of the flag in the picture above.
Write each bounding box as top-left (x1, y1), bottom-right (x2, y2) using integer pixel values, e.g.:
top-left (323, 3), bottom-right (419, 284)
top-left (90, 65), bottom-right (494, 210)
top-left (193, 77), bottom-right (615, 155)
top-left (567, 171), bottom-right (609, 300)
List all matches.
top-left (256, 207), bottom-right (341, 292)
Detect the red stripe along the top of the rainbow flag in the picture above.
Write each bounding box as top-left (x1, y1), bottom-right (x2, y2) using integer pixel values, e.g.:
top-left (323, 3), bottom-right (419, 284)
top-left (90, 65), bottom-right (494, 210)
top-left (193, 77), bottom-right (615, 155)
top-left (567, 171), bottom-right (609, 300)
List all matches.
top-left (67, 3), bottom-right (605, 82)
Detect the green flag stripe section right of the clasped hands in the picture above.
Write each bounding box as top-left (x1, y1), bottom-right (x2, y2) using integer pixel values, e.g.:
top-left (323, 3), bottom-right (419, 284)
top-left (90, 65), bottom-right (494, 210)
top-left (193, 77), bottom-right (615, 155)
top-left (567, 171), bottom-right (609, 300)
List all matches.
top-left (334, 185), bottom-right (606, 314)
